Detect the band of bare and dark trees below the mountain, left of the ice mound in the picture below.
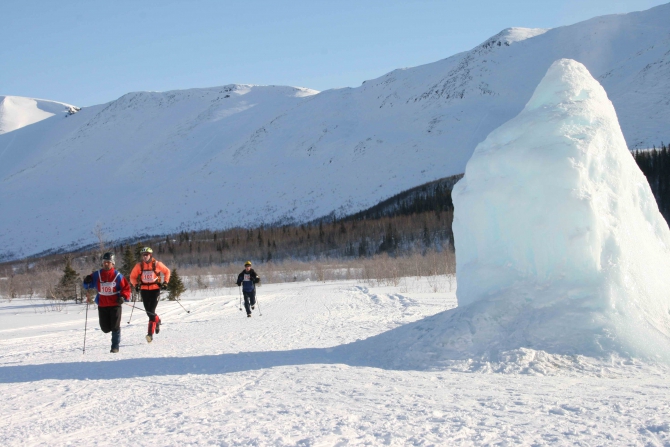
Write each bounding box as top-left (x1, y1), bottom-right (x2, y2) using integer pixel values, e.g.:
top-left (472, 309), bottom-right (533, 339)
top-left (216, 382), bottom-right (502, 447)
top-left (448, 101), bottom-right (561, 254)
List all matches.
top-left (0, 176), bottom-right (460, 299)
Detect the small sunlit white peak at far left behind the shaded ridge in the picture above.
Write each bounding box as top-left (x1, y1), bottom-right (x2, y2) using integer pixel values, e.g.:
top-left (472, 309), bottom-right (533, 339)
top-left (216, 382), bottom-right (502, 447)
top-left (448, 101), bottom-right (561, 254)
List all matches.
top-left (0, 96), bottom-right (73, 134)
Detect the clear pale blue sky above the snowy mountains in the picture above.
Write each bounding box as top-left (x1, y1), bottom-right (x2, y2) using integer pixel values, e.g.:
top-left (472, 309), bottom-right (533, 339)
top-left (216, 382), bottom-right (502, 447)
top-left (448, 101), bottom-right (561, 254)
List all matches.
top-left (0, 0), bottom-right (667, 106)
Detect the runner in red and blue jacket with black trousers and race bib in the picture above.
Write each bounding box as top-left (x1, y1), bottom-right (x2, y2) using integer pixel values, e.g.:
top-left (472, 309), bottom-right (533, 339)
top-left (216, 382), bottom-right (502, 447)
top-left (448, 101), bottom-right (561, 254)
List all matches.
top-left (84, 253), bottom-right (130, 353)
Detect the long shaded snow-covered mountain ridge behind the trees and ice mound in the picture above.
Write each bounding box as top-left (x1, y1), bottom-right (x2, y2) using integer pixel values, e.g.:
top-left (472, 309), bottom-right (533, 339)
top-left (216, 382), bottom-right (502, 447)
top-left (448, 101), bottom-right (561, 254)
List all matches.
top-left (0, 4), bottom-right (670, 258)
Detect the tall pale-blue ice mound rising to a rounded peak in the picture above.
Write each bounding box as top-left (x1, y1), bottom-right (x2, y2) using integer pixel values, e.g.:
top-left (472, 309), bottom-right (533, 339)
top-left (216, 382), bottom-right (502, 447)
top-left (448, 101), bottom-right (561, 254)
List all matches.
top-left (452, 59), bottom-right (670, 360)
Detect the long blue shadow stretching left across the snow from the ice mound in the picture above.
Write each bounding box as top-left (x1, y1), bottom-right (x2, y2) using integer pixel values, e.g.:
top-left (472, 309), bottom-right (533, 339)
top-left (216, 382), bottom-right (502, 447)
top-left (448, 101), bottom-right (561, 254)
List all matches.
top-left (0, 310), bottom-right (452, 383)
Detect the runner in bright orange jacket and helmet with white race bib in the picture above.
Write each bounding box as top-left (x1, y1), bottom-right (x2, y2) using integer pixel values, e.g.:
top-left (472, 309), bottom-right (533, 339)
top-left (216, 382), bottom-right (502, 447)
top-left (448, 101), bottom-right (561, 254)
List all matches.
top-left (130, 247), bottom-right (170, 343)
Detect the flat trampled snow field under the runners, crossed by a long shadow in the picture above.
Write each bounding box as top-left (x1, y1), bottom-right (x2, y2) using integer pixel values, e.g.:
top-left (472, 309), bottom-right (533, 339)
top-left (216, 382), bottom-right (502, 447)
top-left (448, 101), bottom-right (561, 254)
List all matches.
top-left (0, 281), bottom-right (670, 446)
